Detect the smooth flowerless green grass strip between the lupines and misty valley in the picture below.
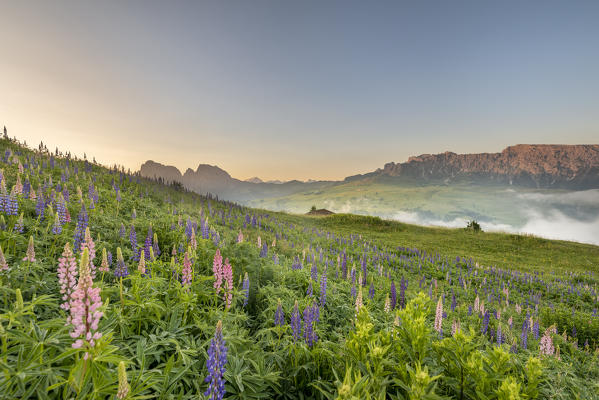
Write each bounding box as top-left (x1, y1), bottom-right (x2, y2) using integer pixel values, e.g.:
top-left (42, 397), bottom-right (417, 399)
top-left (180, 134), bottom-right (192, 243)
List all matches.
top-left (274, 214), bottom-right (599, 274)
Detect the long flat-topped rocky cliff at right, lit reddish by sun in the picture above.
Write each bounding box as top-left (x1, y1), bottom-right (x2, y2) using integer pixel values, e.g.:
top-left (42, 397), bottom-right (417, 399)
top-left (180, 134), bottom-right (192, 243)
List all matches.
top-left (356, 144), bottom-right (599, 189)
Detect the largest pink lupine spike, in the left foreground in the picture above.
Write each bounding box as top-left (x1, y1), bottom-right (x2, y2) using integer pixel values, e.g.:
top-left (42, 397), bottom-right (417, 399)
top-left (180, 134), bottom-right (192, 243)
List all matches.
top-left (70, 248), bottom-right (104, 360)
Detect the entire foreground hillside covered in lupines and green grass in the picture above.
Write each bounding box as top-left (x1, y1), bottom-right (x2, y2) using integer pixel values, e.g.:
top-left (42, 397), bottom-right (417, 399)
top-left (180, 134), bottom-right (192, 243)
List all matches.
top-left (0, 135), bottom-right (599, 399)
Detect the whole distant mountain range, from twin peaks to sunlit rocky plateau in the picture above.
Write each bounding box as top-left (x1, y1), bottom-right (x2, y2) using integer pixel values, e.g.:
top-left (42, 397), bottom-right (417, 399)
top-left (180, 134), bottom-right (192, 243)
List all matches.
top-left (139, 144), bottom-right (599, 201)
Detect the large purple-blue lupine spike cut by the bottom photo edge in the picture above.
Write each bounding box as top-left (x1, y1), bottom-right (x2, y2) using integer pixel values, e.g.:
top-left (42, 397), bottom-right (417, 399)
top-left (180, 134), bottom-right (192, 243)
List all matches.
top-left (204, 321), bottom-right (228, 400)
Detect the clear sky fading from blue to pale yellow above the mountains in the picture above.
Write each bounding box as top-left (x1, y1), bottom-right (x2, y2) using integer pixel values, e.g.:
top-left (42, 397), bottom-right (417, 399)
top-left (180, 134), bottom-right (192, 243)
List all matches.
top-left (0, 0), bottom-right (599, 180)
